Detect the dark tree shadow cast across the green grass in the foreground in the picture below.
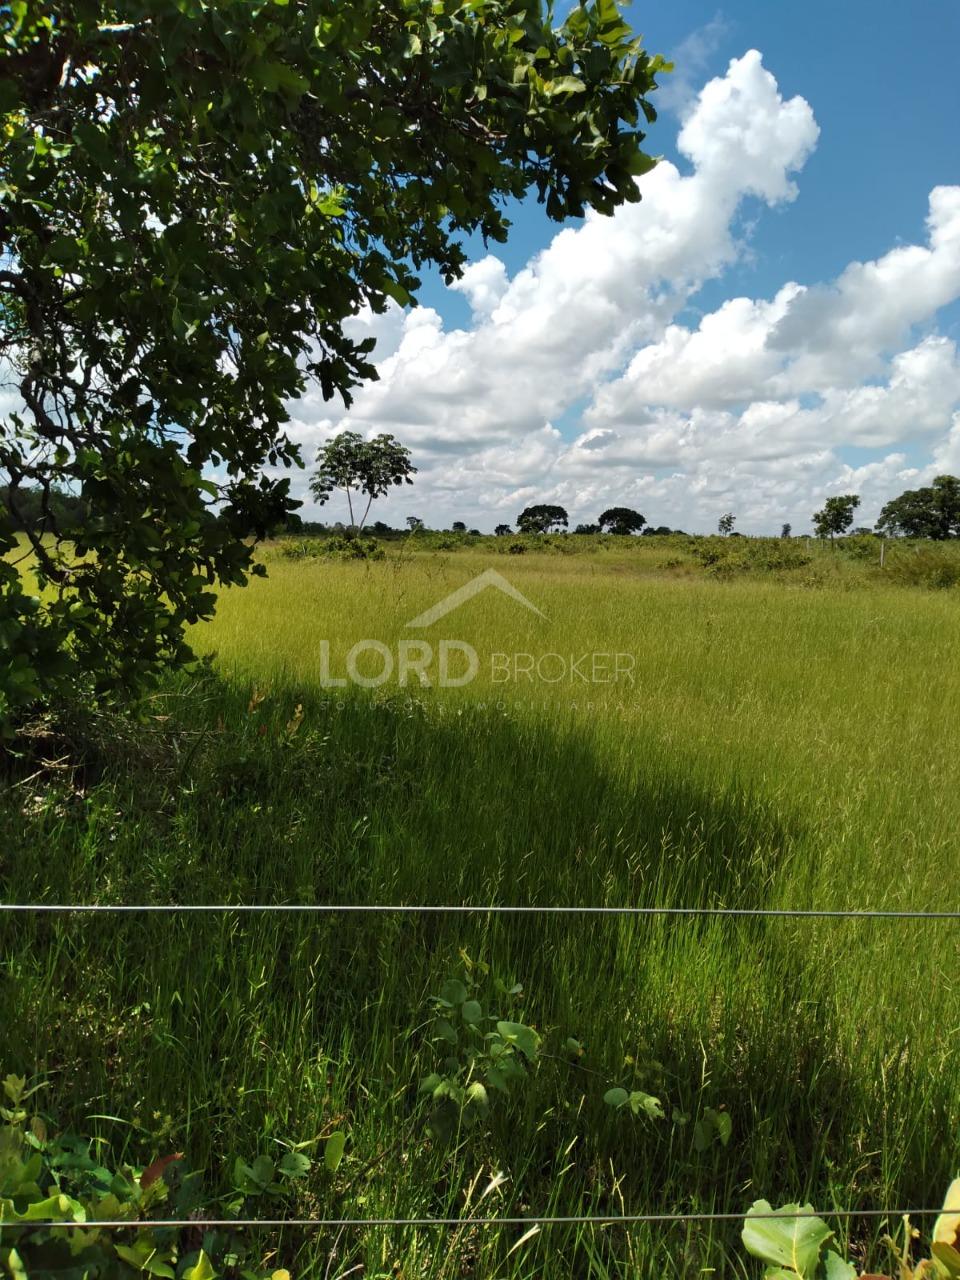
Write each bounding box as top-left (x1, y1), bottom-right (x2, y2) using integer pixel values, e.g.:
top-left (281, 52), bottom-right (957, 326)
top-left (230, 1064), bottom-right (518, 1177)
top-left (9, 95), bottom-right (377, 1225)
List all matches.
top-left (0, 681), bottom-right (955, 1269)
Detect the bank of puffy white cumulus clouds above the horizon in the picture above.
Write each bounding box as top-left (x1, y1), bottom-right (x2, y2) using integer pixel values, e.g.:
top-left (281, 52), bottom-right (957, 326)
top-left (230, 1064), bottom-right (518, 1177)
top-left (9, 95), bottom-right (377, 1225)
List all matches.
top-left (292, 50), bottom-right (960, 531)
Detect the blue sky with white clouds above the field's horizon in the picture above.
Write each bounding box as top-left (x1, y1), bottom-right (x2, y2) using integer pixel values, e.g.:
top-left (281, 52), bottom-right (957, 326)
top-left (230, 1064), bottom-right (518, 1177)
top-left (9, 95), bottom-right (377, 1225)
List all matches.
top-left (291, 0), bottom-right (960, 534)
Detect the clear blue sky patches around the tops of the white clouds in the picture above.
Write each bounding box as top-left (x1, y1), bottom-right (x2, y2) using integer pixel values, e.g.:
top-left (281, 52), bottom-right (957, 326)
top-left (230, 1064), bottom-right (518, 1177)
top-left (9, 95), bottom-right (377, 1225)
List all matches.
top-left (422, 0), bottom-right (960, 338)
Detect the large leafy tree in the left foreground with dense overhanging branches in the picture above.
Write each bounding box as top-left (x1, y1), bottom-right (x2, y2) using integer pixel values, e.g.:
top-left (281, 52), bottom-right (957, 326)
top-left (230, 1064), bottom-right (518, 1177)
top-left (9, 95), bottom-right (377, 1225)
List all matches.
top-left (0, 0), bottom-right (666, 724)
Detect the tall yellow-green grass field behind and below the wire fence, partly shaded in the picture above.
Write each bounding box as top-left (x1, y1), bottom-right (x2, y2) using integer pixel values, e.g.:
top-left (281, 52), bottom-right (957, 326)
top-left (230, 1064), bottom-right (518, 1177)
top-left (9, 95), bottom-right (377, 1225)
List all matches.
top-left (0, 539), bottom-right (960, 1280)
